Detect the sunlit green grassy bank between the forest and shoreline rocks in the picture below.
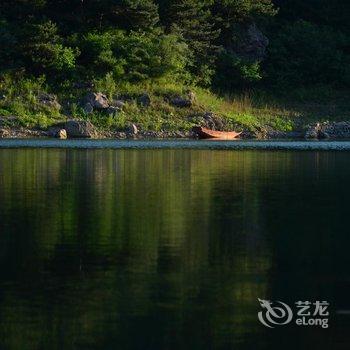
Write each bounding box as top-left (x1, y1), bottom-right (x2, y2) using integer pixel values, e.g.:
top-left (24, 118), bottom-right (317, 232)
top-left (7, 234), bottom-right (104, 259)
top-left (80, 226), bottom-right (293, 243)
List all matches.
top-left (0, 76), bottom-right (350, 137)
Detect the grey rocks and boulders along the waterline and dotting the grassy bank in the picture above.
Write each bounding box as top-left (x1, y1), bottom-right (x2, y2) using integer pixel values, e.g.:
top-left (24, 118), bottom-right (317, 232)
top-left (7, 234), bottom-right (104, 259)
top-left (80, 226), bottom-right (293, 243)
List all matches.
top-left (0, 91), bottom-right (350, 139)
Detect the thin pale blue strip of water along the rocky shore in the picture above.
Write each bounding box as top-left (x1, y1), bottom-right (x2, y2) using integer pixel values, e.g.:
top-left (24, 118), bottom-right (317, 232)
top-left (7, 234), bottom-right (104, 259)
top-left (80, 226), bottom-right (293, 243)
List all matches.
top-left (0, 138), bottom-right (350, 152)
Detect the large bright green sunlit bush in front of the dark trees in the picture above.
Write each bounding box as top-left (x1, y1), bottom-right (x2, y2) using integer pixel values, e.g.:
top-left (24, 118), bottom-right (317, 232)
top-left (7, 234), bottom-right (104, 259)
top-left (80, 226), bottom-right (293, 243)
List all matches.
top-left (80, 30), bottom-right (187, 81)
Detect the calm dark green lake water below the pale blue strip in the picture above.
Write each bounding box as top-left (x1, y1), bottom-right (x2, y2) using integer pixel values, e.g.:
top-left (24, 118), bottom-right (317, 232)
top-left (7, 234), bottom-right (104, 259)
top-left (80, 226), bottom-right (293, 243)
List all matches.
top-left (0, 144), bottom-right (350, 350)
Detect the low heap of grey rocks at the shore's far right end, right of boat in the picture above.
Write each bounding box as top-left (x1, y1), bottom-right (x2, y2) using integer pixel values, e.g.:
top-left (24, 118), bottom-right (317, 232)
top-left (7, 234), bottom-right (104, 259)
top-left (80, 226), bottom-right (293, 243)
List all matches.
top-left (305, 122), bottom-right (350, 139)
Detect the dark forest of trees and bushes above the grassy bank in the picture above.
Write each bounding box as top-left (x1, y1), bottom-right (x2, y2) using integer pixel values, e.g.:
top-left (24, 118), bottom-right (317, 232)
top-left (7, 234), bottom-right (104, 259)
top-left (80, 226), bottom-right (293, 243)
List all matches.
top-left (0, 0), bottom-right (350, 90)
